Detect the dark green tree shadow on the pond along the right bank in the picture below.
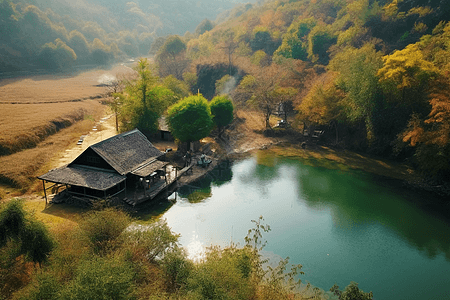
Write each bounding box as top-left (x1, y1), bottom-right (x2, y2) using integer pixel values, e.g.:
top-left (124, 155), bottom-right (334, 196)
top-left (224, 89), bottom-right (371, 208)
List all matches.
top-left (251, 154), bottom-right (450, 261)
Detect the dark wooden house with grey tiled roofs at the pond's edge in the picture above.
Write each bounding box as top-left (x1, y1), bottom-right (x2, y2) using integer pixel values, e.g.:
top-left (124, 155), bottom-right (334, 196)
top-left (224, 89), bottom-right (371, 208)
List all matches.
top-left (38, 129), bottom-right (172, 204)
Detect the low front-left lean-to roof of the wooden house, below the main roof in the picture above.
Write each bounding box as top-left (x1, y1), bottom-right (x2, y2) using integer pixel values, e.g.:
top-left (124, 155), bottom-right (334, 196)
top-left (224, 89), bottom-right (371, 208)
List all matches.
top-left (38, 165), bottom-right (127, 191)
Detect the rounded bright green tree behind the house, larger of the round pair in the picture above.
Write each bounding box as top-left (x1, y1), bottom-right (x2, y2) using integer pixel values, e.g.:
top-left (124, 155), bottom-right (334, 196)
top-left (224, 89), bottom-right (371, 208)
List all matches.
top-left (167, 95), bottom-right (213, 143)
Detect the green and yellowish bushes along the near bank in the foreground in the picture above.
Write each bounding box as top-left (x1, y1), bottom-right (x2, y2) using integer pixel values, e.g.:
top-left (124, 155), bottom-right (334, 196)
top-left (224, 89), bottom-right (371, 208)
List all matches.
top-left (0, 200), bottom-right (373, 300)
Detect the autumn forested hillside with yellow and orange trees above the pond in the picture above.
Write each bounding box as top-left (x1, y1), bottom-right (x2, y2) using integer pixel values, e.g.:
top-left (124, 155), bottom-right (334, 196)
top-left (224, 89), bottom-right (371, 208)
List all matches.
top-left (170, 0), bottom-right (450, 186)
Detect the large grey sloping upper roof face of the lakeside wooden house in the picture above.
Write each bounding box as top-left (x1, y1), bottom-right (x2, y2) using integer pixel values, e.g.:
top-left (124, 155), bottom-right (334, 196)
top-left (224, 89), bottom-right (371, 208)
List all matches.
top-left (86, 129), bottom-right (164, 175)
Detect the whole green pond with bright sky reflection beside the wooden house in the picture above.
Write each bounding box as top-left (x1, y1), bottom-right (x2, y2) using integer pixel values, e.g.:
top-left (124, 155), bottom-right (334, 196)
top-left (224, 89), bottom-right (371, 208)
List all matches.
top-left (156, 152), bottom-right (450, 300)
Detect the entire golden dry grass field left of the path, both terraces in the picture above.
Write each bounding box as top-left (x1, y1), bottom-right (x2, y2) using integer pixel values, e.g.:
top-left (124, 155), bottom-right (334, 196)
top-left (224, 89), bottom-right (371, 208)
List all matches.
top-left (0, 66), bottom-right (131, 199)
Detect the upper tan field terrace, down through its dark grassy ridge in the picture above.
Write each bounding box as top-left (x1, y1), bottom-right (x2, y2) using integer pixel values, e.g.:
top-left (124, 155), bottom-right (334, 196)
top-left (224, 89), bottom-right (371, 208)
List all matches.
top-left (0, 66), bottom-right (130, 155)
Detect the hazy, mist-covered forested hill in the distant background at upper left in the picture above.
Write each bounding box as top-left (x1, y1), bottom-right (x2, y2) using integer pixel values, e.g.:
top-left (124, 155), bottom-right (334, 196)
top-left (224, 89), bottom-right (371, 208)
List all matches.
top-left (0, 0), bottom-right (253, 72)
